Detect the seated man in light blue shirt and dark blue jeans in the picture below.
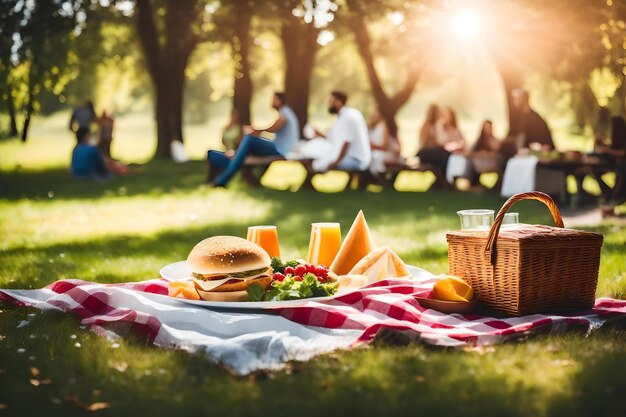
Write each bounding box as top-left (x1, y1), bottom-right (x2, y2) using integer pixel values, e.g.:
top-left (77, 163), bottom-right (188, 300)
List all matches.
top-left (207, 93), bottom-right (300, 187)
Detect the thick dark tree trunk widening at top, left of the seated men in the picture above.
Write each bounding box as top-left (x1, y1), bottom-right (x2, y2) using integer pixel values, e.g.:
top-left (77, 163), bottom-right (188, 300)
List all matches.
top-left (135, 0), bottom-right (204, 157)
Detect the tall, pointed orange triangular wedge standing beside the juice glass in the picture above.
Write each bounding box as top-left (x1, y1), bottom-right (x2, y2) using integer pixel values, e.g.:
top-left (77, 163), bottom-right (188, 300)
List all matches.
top-left (329, 211), bottom-right (374, 275)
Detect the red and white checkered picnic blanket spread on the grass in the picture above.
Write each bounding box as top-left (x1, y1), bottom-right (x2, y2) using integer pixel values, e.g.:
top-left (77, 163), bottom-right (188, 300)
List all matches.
top-left (0, 268), bottom-right (626, 375)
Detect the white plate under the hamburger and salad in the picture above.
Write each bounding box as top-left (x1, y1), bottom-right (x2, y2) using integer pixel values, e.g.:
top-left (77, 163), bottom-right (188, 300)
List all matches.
top-left (160, 261), bottom-right (432, 310)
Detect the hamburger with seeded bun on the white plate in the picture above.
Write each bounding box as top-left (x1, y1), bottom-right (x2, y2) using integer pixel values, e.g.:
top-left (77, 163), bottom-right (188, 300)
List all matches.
top-left (187, 236), bottom-right (272, 301)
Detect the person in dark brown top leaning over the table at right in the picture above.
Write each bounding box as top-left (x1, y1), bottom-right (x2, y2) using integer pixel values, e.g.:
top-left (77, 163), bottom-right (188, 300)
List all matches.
top-left (512, 89), bottom-right (555, 151)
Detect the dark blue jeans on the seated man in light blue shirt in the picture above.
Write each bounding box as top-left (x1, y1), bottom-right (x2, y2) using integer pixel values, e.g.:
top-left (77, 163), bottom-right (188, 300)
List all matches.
top-left (207, 135), bottom-right (281, 187)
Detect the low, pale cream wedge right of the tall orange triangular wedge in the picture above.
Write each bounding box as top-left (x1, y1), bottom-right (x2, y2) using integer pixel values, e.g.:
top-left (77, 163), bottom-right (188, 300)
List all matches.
top-left (349, 246), bottom-right (411, 284)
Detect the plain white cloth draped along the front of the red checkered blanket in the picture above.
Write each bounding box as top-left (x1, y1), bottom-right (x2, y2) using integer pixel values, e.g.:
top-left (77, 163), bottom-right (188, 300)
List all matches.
top-left (5, 284), bottom-right (362, 375)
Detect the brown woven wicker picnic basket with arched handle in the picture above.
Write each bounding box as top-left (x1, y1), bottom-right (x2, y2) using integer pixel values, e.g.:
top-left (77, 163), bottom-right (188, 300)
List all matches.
top-left (447, 192), bottom-right (603, 316)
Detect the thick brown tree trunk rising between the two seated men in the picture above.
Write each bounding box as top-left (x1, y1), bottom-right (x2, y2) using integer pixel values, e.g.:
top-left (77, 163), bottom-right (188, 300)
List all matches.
top-left (280, 15), bottom-right (319, 130)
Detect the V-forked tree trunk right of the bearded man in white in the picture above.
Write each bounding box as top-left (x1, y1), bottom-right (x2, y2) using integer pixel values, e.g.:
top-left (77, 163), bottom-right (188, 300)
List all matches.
top-left (346, 0), bottom-right (423, 136)
